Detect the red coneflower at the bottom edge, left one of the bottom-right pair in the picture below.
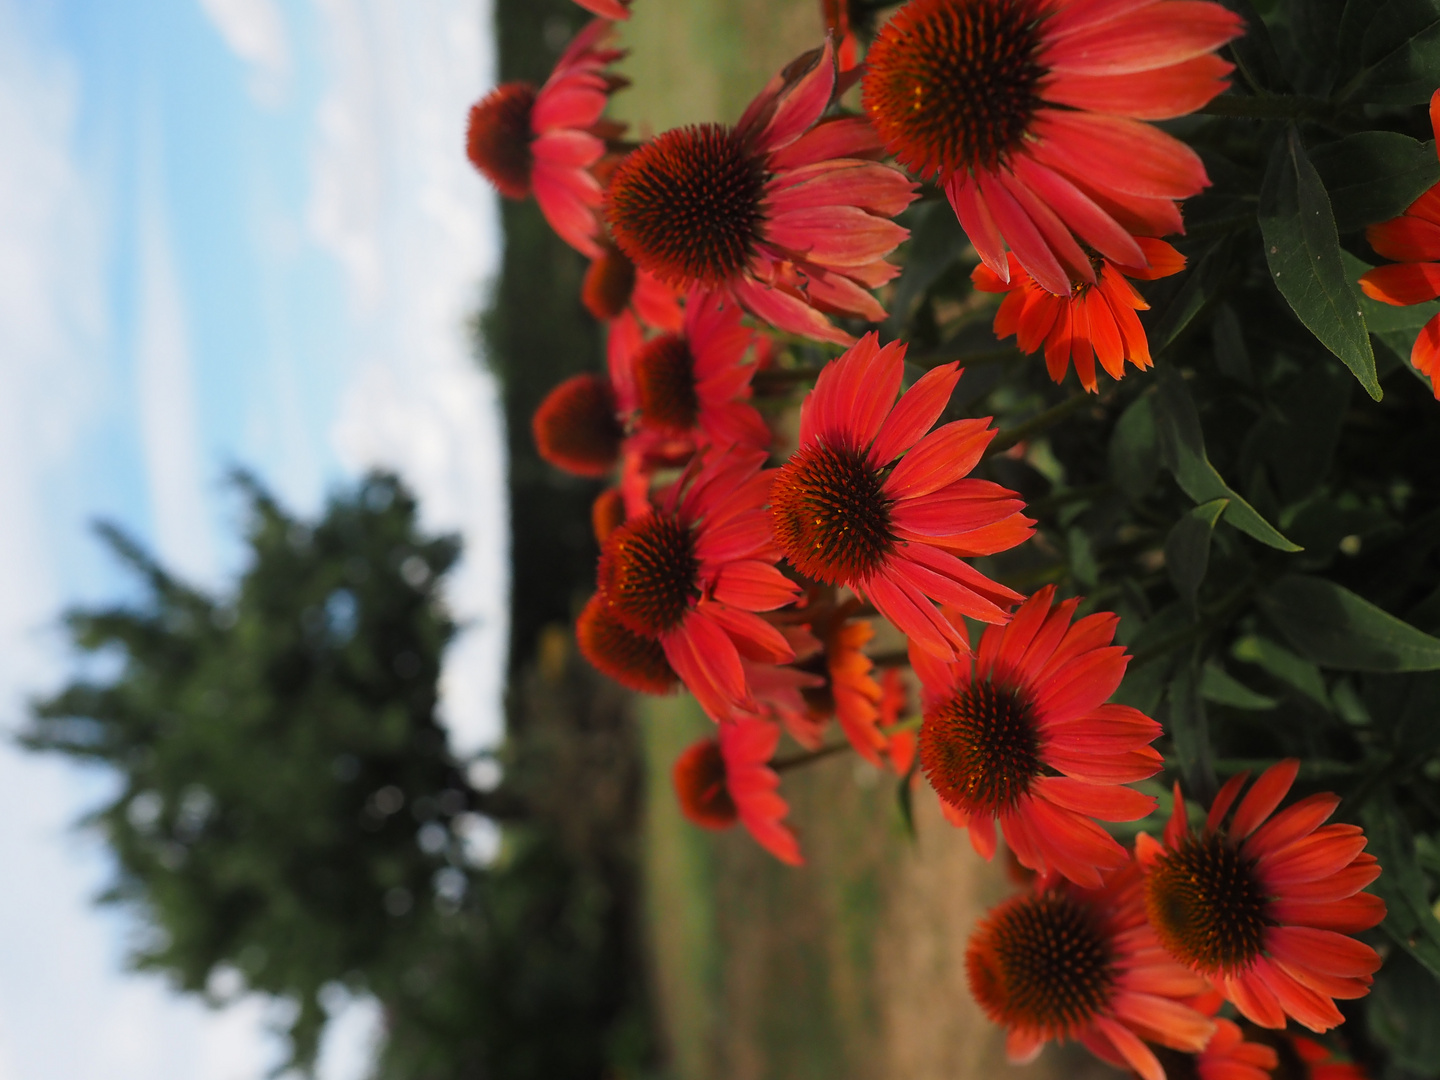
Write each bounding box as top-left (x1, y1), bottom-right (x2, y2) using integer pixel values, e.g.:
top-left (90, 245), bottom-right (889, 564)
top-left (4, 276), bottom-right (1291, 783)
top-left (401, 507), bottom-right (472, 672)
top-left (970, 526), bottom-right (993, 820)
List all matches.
top-left (965, 864), bottom-right (1215, 1080)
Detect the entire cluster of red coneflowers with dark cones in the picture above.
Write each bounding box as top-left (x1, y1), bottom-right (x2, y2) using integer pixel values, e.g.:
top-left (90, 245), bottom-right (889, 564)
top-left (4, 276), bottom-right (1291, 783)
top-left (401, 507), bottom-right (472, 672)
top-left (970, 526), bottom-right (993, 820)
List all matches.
top-left (469, 0), bottom-right (1388, 1080)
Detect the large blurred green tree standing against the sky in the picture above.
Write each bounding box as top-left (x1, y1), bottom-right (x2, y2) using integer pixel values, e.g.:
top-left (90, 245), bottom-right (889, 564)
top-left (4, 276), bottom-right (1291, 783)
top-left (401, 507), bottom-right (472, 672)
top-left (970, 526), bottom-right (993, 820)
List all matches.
top-left (24, 474), bottom-right (482, 1063)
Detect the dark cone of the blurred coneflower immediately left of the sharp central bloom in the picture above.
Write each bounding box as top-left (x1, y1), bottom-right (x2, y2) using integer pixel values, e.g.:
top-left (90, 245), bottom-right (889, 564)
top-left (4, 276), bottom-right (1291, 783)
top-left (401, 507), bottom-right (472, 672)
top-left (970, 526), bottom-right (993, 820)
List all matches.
top-left (599, 511), bottom-right (700, 638)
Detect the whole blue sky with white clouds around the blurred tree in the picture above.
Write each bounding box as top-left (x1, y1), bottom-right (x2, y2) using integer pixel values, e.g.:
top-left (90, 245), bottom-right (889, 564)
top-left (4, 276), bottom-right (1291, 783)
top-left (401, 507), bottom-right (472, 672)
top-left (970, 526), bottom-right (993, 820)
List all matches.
top-left (0, 0), bottom-right (508, 1080)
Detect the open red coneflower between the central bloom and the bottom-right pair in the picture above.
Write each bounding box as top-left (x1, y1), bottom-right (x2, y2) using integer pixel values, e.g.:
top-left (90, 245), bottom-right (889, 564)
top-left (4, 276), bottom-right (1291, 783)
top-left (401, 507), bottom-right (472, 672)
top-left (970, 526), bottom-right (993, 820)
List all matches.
top-left (912, 585), bottom-right (1164, 887)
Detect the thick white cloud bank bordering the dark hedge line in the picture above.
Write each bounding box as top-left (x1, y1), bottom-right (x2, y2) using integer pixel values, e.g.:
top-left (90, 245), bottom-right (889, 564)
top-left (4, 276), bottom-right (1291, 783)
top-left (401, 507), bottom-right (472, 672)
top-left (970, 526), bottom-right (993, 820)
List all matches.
top-left (310, 0), bottom-right (508, 752)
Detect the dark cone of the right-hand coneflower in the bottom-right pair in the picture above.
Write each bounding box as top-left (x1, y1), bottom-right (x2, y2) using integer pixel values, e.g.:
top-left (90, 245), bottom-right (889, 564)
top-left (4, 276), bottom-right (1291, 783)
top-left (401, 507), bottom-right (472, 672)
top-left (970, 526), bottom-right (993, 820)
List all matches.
top-left (1145, 832), bottom-right (1272, 975)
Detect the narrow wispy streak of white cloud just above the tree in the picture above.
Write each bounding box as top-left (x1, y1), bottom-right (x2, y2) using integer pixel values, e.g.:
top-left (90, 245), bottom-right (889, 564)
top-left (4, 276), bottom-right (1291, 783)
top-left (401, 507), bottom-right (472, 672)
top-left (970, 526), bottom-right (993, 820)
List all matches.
top-left (135, 149), bottom-right (216, 582)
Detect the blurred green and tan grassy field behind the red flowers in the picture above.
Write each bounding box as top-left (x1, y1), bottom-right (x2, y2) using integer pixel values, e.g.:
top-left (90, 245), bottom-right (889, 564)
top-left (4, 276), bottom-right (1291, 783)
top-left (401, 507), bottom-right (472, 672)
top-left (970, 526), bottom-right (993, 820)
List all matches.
top-left (613, 0), bottom-right (1115, 1080)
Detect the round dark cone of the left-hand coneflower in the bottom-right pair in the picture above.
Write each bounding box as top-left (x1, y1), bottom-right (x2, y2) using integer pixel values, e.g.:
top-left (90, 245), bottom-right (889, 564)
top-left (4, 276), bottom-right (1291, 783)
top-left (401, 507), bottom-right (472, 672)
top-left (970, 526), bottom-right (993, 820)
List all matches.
top-left (965, 891), bottom-right (1115, 1037)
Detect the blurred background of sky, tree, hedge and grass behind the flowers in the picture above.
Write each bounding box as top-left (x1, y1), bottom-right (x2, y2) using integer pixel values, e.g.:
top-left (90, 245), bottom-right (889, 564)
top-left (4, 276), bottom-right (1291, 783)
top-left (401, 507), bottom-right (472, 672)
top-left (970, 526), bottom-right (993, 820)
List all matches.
top-left (0, 0), bottom-right (1082, 1080)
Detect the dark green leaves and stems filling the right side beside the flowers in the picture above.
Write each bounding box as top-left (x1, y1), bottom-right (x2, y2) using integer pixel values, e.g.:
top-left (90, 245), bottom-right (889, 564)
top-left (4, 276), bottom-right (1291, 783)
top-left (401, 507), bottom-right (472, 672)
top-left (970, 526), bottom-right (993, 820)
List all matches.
top-left (896, 0), bottom-right (1440, 1077)
